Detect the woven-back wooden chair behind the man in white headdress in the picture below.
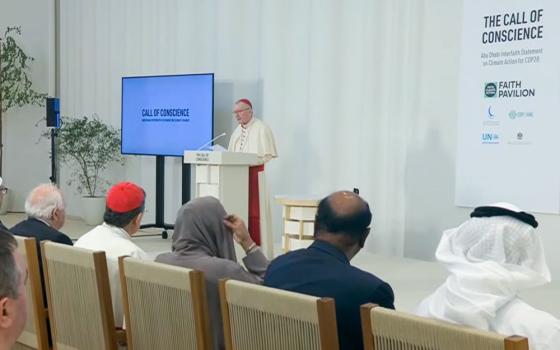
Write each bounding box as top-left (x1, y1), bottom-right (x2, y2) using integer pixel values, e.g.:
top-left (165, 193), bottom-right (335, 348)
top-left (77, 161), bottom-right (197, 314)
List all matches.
top-left (361, 304), bottom-right (529, 350)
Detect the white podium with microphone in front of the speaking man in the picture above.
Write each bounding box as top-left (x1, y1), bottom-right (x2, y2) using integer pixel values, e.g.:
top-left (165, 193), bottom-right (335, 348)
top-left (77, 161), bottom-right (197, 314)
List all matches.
top-left (184, 151), bottom-right (258, 223)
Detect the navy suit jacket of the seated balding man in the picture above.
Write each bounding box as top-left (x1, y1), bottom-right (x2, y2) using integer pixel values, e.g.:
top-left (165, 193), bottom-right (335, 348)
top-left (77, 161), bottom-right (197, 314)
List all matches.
top-left (264, 240), bottom-right (395, 350)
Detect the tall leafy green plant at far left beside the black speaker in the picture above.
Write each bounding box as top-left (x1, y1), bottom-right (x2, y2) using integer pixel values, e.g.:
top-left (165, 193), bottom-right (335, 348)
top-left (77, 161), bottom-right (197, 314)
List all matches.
top-left (0, 27), bottom-right (46, 213)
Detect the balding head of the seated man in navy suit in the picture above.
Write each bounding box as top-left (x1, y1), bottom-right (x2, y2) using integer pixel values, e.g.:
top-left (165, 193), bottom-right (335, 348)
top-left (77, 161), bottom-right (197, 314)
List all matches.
top-left (315, 191), bottom-right (372, 242)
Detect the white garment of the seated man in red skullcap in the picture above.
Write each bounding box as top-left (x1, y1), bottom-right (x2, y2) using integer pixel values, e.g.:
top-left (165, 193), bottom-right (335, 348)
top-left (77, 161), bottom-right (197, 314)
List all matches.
top-left (74, 223), bottom-right (151, 327)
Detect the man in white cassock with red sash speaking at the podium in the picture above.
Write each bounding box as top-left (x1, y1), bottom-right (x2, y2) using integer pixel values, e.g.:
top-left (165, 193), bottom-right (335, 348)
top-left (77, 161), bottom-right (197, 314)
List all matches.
top-left (228, 98), bottom-right (278, 245)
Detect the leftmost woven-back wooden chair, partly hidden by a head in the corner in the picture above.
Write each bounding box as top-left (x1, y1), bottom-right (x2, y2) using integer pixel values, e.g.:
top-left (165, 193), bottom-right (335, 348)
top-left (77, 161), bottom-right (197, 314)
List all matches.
top-left (14, 236), bottom-right (49, 350)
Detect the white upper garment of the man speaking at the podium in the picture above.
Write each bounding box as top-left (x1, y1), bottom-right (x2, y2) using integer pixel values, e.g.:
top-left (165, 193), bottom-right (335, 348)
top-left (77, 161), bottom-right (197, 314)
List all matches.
top-left (228, 117), bottom-right (278, 163)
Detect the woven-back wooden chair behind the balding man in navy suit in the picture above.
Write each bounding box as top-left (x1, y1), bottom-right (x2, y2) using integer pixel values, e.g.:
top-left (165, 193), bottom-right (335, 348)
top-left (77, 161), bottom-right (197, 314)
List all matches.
top-left (219, 280), bottom-right (339, 350)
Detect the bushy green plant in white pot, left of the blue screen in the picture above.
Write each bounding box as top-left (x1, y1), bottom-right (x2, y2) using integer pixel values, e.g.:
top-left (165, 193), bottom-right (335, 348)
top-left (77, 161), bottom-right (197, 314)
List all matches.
top-left (56, 115), bottom-right (124, 225)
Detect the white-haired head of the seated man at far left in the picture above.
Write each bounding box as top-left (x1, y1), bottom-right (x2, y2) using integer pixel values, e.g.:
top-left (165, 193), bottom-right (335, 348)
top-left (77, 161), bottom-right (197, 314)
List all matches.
top-left (25, 184), bottom-right (66, 230)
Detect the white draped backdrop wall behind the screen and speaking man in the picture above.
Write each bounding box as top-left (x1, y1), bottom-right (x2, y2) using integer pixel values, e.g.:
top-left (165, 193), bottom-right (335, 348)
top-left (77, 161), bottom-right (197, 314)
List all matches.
top-left (54, 0), bottom-right (560, 274)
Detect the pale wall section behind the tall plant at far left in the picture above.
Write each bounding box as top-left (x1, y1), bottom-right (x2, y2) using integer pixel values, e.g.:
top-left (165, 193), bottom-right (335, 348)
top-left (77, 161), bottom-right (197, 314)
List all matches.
top-left (0, 0), bottom-right (55, 211)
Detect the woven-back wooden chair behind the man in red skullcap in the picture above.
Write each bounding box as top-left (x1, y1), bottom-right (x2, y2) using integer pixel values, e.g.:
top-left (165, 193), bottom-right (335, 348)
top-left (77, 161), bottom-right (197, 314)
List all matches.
top-left (41, 242), bottom-right (126, 350)
